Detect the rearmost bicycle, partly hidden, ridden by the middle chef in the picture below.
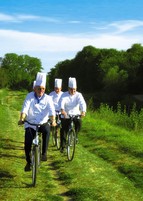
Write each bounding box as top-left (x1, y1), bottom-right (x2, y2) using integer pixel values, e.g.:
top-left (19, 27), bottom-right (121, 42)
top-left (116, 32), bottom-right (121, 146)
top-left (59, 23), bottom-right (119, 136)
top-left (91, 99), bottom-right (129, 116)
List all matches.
top-left (51, 111), bottom-right (61, 150)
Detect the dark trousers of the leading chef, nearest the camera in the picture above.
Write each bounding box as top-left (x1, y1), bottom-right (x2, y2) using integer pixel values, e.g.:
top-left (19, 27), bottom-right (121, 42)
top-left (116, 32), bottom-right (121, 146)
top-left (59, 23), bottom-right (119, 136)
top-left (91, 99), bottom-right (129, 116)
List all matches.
top-left (24, 124), bottom-right (50, 163)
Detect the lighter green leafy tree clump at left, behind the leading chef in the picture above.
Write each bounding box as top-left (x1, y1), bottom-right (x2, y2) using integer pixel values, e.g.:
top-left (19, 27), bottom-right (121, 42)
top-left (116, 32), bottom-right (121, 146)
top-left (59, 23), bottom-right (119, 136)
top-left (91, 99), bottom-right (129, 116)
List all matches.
top-left (0, 53), bottom-right (43, 90)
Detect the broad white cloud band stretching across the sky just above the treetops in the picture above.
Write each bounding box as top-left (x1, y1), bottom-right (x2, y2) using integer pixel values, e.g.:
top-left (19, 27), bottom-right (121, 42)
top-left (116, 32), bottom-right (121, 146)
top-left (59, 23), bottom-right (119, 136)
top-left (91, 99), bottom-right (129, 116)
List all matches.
top-left (0, 19), bottom-right (143, 71)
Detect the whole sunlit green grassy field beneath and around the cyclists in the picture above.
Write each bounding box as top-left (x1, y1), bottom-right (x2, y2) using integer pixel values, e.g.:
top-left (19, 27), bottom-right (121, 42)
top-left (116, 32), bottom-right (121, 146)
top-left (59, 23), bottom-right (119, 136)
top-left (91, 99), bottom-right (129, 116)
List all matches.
top-left (0, 90), bottom-right (143, 201)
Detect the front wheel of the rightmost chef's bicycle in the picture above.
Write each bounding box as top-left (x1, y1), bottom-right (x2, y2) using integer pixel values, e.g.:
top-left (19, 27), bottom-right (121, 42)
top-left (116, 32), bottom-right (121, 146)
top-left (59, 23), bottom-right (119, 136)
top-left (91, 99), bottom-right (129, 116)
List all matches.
top-left (67, 129), bottom-right (76, 161)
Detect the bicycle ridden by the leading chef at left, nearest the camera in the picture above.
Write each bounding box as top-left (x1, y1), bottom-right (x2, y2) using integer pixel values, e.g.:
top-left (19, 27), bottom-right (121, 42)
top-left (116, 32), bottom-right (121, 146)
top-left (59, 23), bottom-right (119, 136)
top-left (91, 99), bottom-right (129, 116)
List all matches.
top-left (24, 120), bottom-right (42, 186)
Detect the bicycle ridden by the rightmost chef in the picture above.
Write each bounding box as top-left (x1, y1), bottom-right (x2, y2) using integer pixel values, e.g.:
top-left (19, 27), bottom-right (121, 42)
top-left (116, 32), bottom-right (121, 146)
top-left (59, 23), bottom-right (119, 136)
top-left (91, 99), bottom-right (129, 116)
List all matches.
top-left (66, 115), bottom-right (80, 161)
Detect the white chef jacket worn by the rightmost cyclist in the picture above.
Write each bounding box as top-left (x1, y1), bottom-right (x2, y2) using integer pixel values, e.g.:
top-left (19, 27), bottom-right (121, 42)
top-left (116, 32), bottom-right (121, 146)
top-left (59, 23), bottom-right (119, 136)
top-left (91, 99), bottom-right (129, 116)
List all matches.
top-left (60, 91), bottom-right (86, 118)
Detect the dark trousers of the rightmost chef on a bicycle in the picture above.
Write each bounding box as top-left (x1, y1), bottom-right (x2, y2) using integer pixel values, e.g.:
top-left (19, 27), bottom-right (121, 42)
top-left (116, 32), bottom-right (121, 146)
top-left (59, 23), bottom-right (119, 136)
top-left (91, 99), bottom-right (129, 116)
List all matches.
top-left (60, 118), bottom-right (81, 147)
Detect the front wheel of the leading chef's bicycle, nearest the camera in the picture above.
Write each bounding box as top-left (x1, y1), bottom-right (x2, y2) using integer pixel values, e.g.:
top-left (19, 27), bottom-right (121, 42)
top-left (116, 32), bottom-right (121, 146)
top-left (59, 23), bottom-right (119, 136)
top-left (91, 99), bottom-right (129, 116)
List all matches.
top-left (31, 146), bottom-right (38, 186)
